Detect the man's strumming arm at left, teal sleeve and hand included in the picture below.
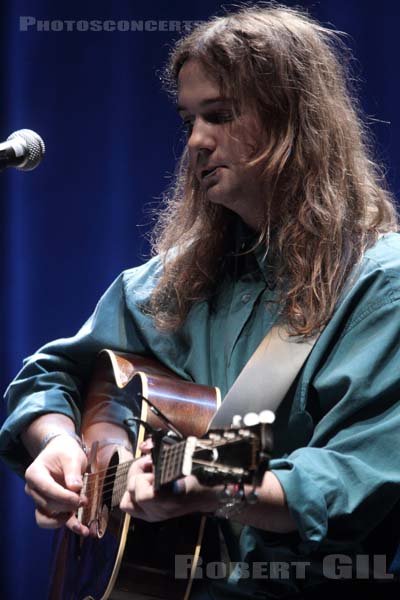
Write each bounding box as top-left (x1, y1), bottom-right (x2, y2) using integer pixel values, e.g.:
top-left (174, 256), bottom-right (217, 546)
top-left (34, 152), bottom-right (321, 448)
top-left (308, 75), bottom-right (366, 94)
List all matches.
top-left (0, 270), bottom-right (162, 534)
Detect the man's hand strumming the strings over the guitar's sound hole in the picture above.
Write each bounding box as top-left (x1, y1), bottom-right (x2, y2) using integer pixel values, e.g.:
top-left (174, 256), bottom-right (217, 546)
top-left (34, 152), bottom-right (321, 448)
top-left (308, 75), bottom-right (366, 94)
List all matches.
top-left (25, 434), bottom-right (89, 536)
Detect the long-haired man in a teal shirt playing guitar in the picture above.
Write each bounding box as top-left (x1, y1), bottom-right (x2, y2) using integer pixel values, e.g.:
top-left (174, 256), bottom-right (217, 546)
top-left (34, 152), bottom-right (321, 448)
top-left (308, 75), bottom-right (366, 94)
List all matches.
top-left (0, 7), bottom-right (400, 598)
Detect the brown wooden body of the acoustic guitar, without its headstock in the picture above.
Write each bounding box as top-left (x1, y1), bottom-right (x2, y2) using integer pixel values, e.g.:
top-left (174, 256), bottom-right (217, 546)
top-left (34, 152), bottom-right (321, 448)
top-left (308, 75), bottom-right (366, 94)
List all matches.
top-left (49, 350), bottom-right (220, 600)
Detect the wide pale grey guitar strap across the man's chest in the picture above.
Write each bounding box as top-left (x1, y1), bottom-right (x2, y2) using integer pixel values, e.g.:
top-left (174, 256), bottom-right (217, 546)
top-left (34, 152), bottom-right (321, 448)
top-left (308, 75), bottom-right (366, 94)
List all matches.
top-left (210, 326), bottom-right (320, 428)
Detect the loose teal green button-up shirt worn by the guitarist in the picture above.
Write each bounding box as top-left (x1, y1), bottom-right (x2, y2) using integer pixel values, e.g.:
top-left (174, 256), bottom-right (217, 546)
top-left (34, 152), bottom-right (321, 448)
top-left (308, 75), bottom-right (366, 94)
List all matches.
top-left (0, 234), bottom-right (400, 597)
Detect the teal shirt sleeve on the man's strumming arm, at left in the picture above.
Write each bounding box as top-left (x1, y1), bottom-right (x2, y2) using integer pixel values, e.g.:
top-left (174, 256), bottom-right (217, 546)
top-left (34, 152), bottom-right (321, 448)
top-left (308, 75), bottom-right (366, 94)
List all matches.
top-left (0, 268), bottom-right (151, 475)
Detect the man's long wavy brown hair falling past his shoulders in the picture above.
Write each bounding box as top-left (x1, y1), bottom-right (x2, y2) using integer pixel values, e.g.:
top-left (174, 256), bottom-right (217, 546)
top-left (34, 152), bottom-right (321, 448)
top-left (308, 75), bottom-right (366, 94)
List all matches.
top-left (150, 4), bottom-right (397, 336)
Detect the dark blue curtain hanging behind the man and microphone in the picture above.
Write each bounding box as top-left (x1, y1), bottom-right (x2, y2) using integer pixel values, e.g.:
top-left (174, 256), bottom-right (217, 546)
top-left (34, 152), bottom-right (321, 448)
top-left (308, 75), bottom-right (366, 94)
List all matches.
top-left (0, 0), bottom-right (400, 600)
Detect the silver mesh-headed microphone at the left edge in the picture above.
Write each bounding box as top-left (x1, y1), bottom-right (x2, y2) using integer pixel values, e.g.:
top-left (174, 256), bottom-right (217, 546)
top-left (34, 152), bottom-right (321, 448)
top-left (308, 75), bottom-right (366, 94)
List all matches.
top-left (0, 129), bottom-right (46, 171)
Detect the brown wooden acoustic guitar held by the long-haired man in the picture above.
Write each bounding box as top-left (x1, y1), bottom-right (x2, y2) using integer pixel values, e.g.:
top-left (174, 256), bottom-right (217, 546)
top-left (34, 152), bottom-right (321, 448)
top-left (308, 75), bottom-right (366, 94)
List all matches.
top-left (48, 350), bottom-right (272, 600)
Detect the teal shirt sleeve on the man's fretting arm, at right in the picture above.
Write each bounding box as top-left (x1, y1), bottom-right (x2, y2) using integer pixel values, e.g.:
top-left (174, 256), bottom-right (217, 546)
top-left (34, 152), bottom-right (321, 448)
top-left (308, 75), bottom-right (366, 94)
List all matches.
top-left (271, 295), bottom-right (400, 552)
